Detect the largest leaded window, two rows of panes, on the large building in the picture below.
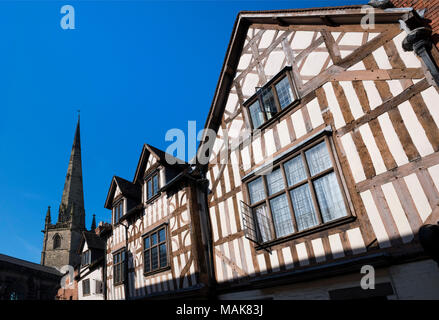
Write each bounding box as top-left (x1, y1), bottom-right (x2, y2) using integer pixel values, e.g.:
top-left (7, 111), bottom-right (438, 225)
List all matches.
top-left (247, 136), bottom-right (348, 242)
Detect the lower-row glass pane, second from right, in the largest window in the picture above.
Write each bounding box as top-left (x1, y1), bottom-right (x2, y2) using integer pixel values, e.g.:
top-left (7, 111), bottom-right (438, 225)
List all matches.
top-left (291, 184), bottom-right (318, 231)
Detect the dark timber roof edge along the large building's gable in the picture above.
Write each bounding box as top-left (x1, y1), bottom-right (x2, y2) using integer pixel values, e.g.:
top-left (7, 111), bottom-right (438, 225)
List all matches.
top-left (197, 5), bottom-right (412, 170)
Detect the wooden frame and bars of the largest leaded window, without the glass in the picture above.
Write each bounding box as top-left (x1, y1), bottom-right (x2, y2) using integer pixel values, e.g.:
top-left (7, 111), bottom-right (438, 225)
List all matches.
top-left (243, 134), bottom-right (356, 249)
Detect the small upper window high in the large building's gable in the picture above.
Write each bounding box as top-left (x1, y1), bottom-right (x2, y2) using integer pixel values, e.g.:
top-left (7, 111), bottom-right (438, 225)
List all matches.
top-left (245, 67), bottom-right (298, 129)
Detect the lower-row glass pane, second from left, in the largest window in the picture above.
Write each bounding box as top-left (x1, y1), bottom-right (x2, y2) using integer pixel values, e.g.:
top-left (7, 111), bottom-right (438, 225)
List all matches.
top-left (270, 193), bottom-right (294, 237)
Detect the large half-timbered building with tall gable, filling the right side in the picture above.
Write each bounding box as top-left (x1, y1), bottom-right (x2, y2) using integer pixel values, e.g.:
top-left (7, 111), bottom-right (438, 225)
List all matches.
top-left (197, 6), bottom-right (439, 299)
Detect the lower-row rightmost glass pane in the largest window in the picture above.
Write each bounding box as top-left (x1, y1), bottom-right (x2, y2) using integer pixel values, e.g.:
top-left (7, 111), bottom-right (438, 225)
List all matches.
top-left (314, 172), bottom-right (347, 222)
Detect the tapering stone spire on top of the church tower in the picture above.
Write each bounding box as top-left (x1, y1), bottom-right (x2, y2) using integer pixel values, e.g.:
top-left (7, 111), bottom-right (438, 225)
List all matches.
top-left (58, 115), bottom-right (85, 229)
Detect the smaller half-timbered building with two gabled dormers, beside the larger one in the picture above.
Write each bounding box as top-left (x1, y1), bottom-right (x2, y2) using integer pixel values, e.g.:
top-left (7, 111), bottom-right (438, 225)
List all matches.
top-left (105, 144), bottom-right (209, 300)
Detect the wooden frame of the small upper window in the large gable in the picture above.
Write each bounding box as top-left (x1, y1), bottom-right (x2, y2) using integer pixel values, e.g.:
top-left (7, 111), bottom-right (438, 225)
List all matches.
top-left (244, 66), bottom-right (300, 130)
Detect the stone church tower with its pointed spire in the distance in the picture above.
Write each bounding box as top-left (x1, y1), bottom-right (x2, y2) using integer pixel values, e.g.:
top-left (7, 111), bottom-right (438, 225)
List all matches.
top-left (41, 118), bottom-right (86, 267)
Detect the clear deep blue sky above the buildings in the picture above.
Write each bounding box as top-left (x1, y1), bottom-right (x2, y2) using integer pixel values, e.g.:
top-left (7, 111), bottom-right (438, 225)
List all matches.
top-left (0, 0), bottom-right (367, 263)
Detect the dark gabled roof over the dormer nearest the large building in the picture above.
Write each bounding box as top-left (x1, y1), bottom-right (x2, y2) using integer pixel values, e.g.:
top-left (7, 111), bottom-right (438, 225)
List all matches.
top-left (133, 143), bottom-right (189, 184)
